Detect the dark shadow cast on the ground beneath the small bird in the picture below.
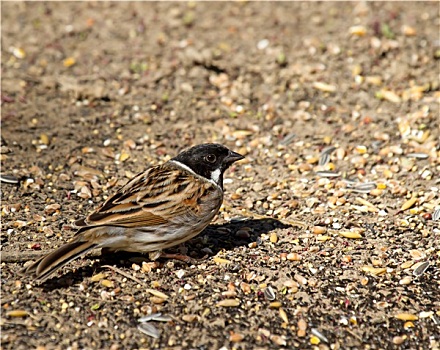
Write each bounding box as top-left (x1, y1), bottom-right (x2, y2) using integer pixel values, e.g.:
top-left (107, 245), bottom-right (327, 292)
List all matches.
top-left (41, 218), bottom-right (292, 291)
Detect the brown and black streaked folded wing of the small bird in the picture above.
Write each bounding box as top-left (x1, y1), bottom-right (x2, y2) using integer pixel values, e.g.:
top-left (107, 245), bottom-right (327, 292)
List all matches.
top-left (75, 163), bottom-right (215, 228)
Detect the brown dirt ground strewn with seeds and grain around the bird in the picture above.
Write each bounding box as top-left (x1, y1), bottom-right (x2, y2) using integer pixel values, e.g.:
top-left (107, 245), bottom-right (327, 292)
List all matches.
top-left (1, 2), bottom-right (440, 349)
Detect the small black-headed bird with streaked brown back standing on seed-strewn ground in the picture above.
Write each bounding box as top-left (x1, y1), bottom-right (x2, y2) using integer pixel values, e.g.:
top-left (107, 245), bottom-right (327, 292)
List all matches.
top-left (22, 143), bottom-right (244, 282)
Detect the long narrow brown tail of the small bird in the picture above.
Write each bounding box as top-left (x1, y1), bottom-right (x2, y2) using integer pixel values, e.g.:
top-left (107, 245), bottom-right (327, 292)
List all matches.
top-left (21, 241), bottom-right (97, 282)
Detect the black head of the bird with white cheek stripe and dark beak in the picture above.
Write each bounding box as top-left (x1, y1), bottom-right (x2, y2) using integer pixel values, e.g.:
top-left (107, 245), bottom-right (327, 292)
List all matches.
top-left (172, 143), bottom-right (244, 188)
